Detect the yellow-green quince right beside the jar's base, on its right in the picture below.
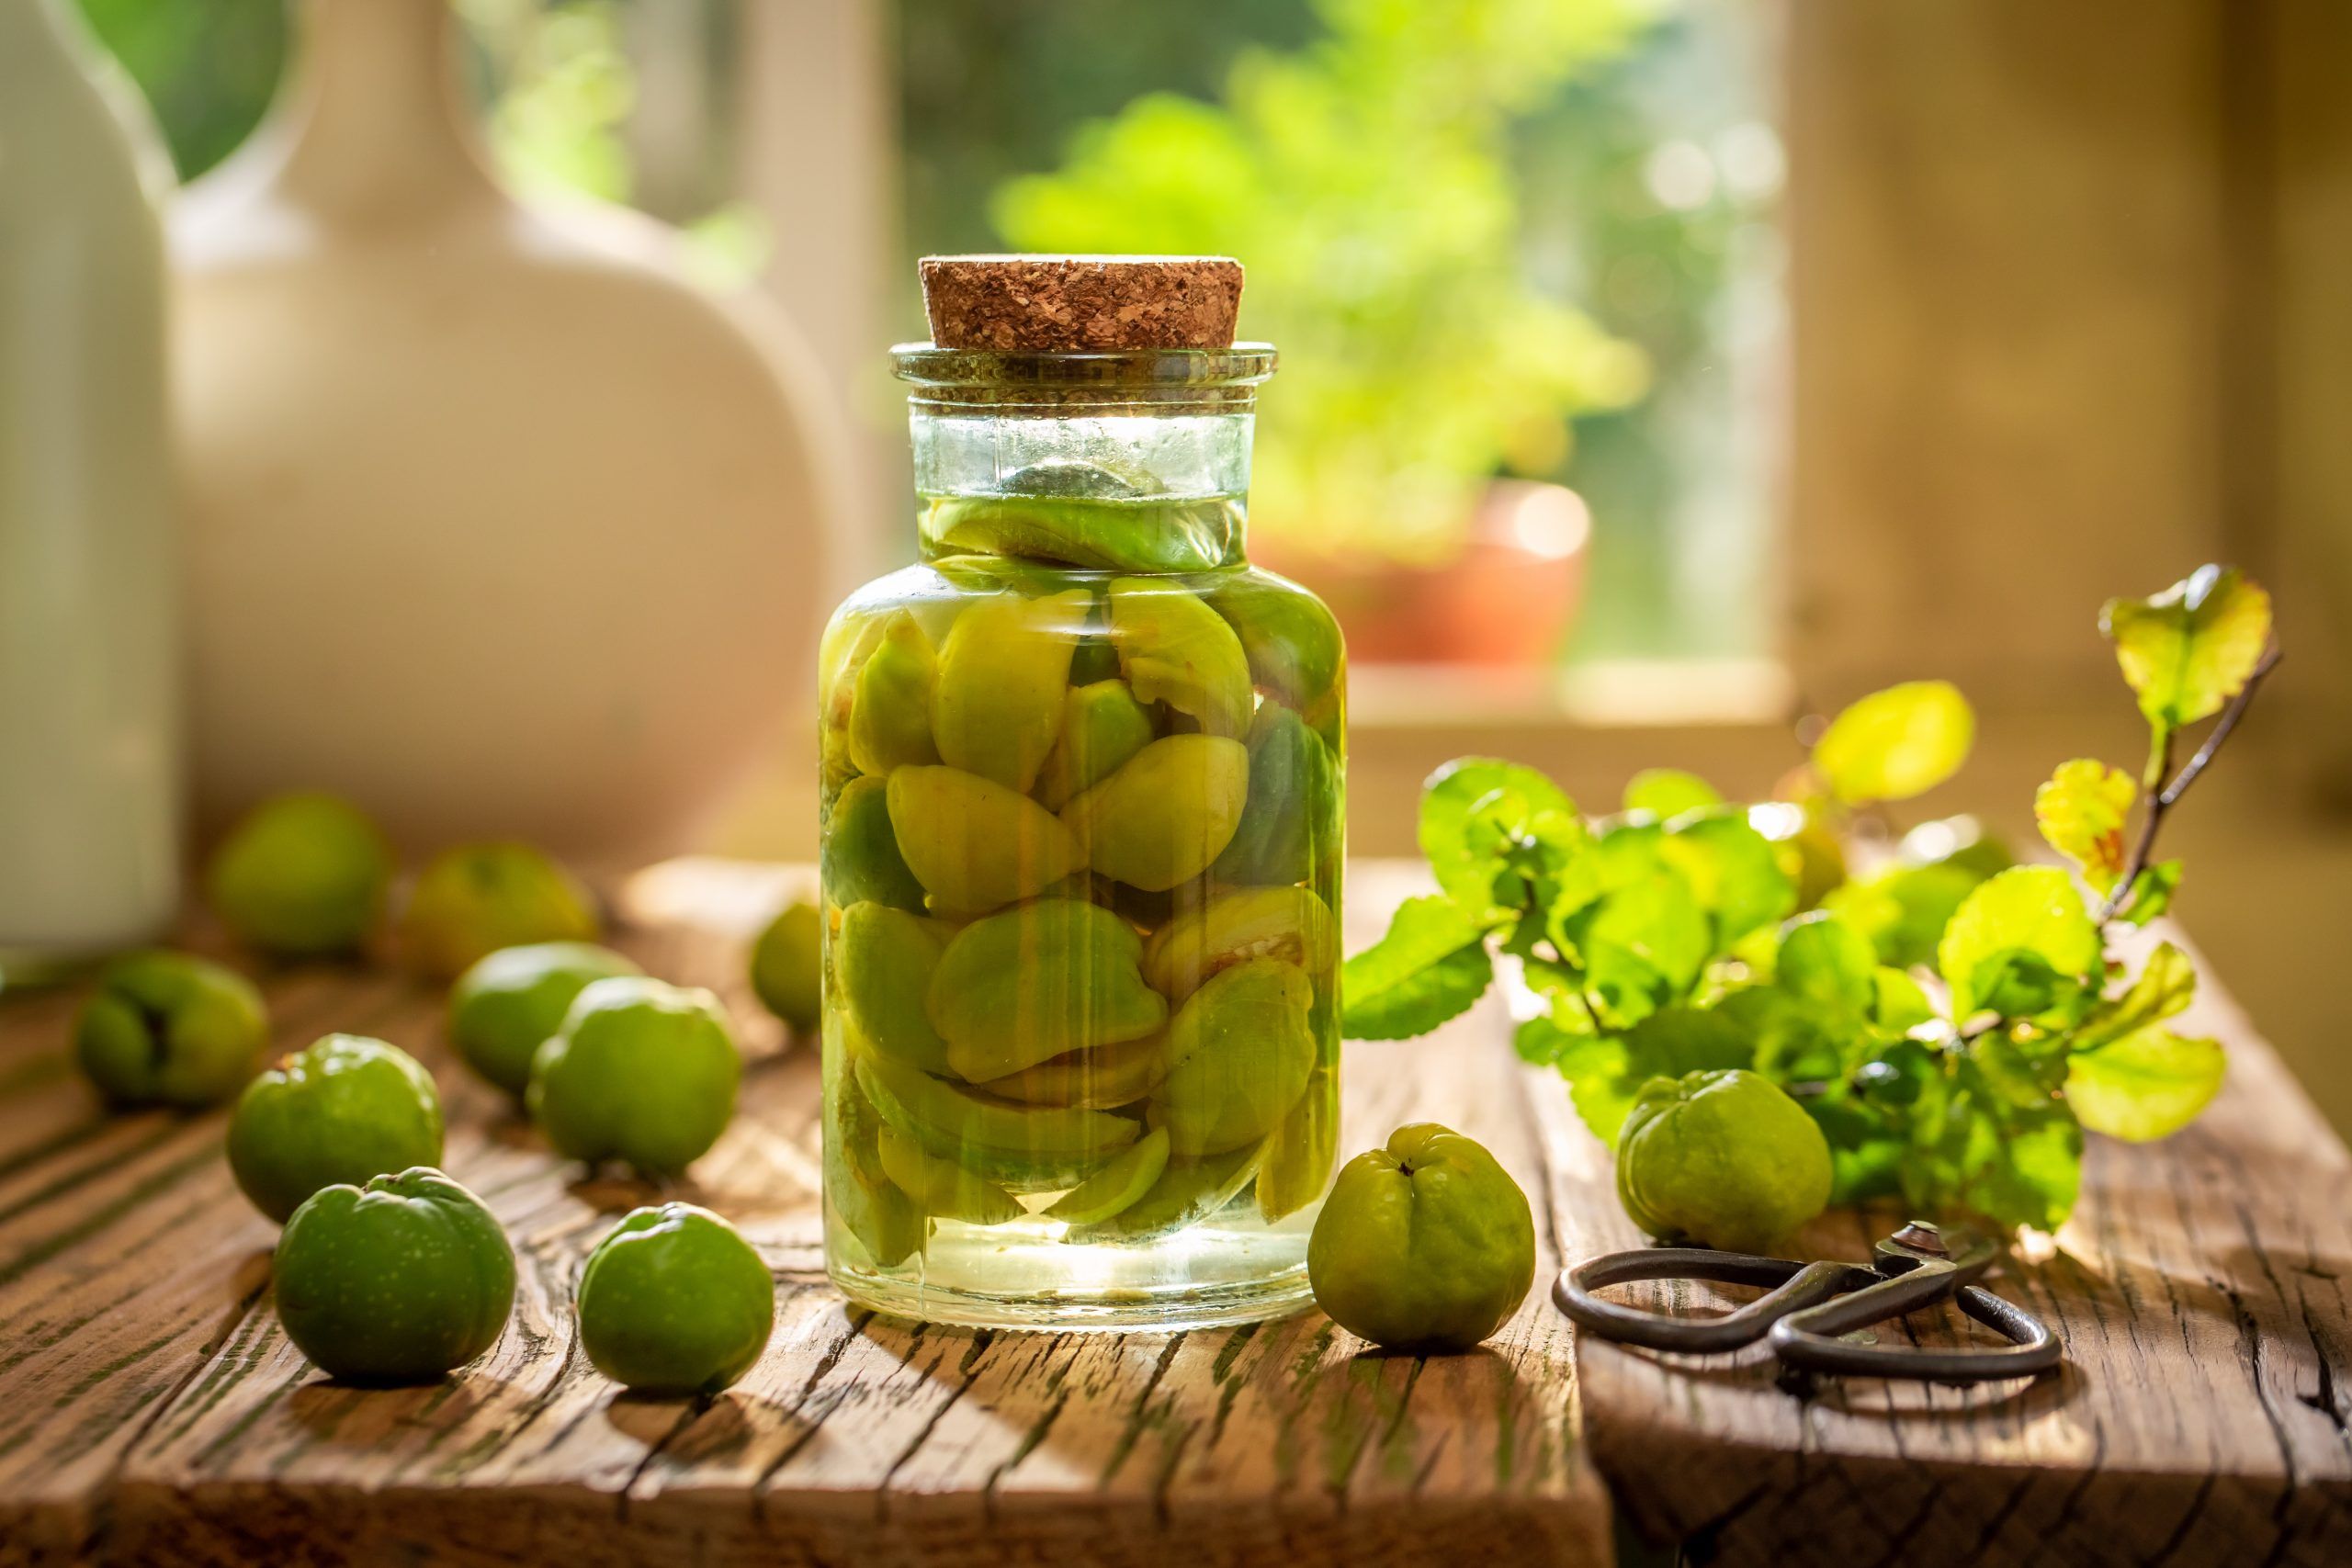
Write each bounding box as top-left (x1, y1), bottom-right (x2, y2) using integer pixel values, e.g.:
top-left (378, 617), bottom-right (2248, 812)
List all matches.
top-left (1307, 1122), bottom-right (1536, 1352)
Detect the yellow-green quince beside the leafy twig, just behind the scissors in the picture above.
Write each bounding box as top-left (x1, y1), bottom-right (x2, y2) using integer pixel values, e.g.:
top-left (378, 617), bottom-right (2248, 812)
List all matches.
top-left (1618, 1067), bottom-right (1830, 1253)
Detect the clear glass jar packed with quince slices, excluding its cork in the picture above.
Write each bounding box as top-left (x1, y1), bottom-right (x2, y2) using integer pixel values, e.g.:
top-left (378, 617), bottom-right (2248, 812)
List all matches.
top-left (819, 344), bottom-right (1345, 1328)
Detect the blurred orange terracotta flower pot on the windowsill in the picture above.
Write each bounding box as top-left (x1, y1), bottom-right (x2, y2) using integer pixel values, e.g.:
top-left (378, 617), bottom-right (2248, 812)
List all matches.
top-left (1251, 479), bottom-right (1592, 668)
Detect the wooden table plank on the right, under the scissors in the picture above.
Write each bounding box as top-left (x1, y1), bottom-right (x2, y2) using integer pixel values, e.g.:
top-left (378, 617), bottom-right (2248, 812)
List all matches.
top-left (1532, 933), bottom-right (2352, 1568)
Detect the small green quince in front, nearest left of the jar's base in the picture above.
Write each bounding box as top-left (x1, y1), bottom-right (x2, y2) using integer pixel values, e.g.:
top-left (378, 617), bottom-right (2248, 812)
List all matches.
top-left (576, 1203), bottom-right (776, 1396)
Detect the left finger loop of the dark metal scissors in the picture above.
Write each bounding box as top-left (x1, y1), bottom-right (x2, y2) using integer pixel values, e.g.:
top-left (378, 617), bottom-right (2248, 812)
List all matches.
top-left (1553, 1246), bottom-right (1879, 1354)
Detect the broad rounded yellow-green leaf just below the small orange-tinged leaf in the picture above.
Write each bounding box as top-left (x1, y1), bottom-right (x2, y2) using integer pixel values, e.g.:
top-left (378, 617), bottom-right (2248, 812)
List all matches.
top-left (1936, 865), bottom-right (2103, 1022)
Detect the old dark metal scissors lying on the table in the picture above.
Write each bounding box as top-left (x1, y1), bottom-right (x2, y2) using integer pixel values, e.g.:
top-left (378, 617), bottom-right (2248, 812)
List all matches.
top-left (1553, 1220), bottom-right (2065, 1384)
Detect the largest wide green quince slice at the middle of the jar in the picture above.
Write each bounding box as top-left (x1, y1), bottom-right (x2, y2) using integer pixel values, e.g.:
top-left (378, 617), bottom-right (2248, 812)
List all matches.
top-left (929, 898), bottom-right (1169, 1084)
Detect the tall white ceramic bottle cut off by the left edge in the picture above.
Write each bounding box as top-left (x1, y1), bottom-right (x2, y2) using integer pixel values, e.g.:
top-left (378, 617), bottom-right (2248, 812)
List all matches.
top-left (0, 0), bottom-right (181, 968)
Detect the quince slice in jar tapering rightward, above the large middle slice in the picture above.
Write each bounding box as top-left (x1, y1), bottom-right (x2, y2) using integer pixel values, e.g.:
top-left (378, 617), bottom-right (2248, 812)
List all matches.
top-left (889, 766), bottom-right (1087, 915)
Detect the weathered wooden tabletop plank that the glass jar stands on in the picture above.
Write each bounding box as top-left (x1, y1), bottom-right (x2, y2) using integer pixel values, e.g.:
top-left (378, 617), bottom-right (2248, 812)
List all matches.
top-left (0, 872), bottom-right (1609, 1565)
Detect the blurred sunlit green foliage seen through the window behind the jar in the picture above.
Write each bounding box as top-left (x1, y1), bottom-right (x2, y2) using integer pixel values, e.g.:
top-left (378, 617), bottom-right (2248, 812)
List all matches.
top-left (83, 0), bottom-right (1781, 656)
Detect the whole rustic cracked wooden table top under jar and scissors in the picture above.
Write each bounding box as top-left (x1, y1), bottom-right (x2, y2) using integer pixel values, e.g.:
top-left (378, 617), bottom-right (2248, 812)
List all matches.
top-left (0, 865), bottom-right (2352, 1568)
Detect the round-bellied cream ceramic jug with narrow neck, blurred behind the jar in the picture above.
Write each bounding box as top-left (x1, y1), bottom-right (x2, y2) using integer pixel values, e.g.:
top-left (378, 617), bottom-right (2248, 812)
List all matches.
top-left (172, 0), bottom-right (837, 865)
